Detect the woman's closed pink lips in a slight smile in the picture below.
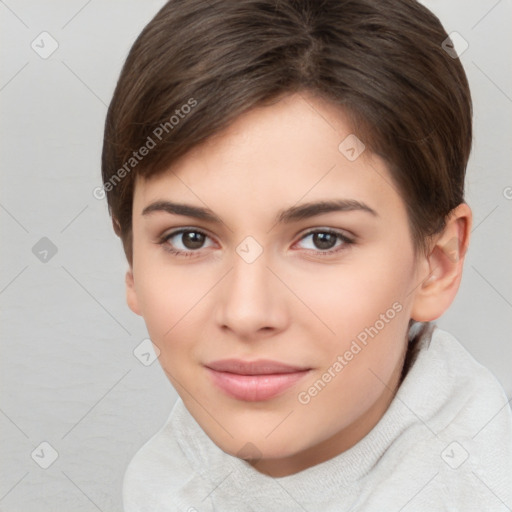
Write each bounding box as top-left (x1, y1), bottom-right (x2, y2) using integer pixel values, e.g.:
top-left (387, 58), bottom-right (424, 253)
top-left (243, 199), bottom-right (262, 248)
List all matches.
top-left (206, 359), bottom-right (310, 402)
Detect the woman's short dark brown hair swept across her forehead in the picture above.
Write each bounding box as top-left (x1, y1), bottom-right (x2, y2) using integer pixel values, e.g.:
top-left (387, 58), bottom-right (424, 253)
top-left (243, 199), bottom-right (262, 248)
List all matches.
top-left (102, 0), bottom-right (472, 263)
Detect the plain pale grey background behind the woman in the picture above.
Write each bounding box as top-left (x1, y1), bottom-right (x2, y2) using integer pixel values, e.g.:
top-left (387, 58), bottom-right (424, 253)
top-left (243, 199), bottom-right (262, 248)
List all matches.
top-left (0, 0), bottom-right (512, 512)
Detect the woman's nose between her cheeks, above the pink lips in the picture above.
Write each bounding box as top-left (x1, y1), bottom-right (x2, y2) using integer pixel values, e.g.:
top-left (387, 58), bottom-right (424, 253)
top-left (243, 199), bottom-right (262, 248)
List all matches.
top-left (216, 252), bottom-right (289, 340)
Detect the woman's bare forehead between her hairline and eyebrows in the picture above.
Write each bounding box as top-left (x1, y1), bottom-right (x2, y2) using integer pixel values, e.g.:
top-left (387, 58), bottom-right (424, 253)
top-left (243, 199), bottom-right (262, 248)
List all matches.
top-left (134, 93), bottom-right (405, 224)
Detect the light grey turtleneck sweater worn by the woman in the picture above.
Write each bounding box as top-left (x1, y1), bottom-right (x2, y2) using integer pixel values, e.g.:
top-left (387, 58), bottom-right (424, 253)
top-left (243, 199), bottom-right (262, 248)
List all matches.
top-left (123, 328), bottom-right (512, 512)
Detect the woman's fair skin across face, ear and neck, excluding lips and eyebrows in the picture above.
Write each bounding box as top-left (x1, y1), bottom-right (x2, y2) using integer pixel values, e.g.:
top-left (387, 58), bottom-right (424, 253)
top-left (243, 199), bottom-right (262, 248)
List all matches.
top-left (126, 92), bottom-right (471, 476)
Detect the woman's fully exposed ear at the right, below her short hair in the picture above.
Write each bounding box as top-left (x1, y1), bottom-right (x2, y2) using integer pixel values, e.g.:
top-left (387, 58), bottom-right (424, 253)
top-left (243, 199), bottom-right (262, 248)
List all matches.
top-left (411, 203), bottom-right (472, 322)
